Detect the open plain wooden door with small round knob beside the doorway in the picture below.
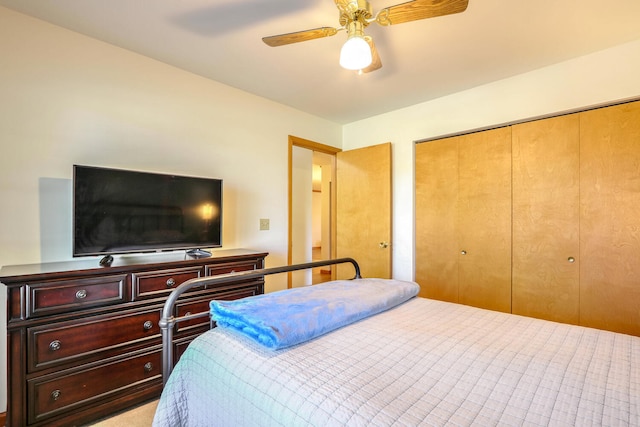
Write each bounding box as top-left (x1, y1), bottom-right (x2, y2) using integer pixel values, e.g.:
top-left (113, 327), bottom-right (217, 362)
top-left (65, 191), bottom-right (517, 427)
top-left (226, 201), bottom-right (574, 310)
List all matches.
top-left (336, 143), bottom-right (392, 279)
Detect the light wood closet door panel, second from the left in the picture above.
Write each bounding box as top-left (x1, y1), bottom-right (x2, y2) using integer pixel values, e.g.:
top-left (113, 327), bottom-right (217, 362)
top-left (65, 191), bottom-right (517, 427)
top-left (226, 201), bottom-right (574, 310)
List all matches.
top-left (458, 127), bottom-right (511, 312)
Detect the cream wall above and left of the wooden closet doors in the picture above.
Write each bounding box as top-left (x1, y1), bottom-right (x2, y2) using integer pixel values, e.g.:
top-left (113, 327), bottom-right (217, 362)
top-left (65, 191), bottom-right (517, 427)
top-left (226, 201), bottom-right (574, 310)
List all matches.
top-left (342, 40), bottom-right (640, 280)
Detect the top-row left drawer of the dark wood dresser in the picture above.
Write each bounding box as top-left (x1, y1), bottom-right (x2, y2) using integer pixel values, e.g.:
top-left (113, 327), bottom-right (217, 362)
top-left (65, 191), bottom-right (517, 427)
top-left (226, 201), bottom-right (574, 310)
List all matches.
top-left (25, 274), bottom-right (127, 317)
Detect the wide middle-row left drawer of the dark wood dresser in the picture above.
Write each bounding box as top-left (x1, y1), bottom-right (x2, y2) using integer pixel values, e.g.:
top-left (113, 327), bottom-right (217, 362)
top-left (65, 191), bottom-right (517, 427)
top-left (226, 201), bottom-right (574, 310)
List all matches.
top-left (27, 309), bottom-right (160, 372)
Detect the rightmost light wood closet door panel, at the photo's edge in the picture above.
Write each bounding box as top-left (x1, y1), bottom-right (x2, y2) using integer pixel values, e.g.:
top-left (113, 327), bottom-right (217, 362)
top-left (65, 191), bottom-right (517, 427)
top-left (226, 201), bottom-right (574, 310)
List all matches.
top-left (580, 102), bottom-right (640, 335)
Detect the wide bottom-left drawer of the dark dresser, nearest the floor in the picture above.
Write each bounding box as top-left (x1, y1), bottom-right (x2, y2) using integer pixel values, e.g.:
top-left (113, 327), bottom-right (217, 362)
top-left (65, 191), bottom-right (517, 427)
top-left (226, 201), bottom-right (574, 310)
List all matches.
top-left (27, 349), bottom-right (162, 423)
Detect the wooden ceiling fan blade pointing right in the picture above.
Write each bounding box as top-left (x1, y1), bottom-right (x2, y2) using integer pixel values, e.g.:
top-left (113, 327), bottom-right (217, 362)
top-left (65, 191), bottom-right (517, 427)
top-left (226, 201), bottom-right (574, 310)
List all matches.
top-left (376, 0), bottom-right (469, 25)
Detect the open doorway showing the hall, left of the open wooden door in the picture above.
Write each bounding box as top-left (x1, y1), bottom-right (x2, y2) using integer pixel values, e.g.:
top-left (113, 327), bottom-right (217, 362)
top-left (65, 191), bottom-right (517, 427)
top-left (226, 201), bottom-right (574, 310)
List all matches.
top-left (287, 136), bottom-right (341, 288)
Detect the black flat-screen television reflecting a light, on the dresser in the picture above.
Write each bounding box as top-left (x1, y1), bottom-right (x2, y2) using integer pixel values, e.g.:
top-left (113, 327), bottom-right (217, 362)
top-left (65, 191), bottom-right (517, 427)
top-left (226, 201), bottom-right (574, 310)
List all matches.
top-left (73, 165), bottom-right (222, 256)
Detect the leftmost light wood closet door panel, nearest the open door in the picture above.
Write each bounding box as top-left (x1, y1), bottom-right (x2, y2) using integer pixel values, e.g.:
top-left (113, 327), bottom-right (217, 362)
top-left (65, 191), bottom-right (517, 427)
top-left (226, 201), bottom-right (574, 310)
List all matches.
top-left (415, 138), bottom-right (458, 302)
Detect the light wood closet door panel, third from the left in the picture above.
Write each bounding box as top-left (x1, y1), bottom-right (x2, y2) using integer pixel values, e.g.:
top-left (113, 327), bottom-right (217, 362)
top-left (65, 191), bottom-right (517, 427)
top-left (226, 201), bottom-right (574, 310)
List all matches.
top-left (512, 114), bottom-right (580, 324)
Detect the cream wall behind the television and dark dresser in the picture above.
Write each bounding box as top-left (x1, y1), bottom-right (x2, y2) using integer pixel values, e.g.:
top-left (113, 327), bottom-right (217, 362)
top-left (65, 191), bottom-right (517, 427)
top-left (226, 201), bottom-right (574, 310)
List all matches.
top-left (0, 7), bottom-right (341, 412)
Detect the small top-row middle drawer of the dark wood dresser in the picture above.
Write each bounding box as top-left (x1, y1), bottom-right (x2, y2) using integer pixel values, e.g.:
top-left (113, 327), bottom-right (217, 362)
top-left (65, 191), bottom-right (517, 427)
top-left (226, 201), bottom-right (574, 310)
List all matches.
top-left (131, 267), bottom-right (202, 300)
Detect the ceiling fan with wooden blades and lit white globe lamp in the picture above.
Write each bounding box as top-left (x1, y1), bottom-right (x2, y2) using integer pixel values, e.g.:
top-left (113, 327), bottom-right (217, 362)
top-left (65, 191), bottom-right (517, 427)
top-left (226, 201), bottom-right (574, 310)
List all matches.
top-left (262, 0), bottom-right (469, 73)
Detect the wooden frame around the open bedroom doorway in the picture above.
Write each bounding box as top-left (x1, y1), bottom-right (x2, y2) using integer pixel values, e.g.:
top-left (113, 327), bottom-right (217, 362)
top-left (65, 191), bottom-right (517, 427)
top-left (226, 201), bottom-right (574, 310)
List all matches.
top-left (287, 135), bottom-right (342, 288)
